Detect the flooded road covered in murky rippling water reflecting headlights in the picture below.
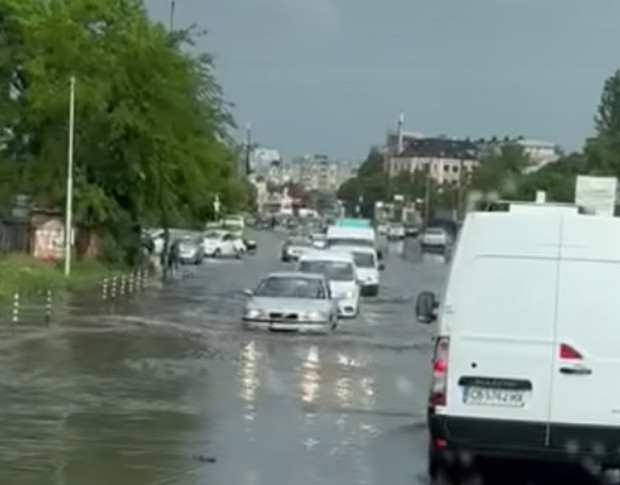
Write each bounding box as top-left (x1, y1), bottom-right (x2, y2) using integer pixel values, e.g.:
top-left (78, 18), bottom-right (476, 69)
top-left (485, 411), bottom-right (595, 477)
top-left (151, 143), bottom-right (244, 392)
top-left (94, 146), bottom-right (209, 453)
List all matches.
top-left (0, 232), bottom-right (604, 485)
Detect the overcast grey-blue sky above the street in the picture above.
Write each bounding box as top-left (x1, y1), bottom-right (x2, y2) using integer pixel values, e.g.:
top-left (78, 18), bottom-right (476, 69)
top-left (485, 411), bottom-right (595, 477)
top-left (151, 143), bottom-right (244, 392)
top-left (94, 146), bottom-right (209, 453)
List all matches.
top-left (146, 0), bottom-right (620, 157)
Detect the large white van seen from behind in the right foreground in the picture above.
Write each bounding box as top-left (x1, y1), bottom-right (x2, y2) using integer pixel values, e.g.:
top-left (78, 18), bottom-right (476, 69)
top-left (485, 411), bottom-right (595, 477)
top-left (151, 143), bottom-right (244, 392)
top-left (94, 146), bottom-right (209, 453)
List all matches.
top-left (416, 204), bottom-right (620, 476)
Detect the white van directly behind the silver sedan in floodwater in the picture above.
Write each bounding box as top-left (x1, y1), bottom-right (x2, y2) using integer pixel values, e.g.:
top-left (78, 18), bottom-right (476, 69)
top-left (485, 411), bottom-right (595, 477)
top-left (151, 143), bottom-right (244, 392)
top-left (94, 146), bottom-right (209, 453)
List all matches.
top-left (297, 251), bottom-right (360, 318)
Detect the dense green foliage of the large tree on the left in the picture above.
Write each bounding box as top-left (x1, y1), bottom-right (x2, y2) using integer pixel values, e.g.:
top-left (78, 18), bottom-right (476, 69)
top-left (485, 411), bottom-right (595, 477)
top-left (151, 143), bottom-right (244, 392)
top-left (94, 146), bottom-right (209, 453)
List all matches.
top-left (0, 0), bottom-right (251, 260)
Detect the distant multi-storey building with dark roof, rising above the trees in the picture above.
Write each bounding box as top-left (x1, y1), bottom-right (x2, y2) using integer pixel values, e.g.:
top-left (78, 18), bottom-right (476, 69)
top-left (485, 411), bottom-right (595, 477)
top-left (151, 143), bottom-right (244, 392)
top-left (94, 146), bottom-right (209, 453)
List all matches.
top-left (385, 137), bottom-right (480, 184)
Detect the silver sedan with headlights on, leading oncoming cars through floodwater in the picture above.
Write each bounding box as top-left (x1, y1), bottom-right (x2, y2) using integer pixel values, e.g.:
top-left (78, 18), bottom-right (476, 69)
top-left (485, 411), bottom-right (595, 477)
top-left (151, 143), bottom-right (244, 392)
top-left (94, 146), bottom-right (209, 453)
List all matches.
top-left (243, 272), bottom-right (338, 333)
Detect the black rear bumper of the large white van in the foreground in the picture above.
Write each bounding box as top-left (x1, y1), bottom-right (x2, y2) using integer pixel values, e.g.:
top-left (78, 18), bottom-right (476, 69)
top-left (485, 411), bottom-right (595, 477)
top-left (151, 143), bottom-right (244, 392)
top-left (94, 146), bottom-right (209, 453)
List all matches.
top-left (428, 412), bottom-right (620, 467)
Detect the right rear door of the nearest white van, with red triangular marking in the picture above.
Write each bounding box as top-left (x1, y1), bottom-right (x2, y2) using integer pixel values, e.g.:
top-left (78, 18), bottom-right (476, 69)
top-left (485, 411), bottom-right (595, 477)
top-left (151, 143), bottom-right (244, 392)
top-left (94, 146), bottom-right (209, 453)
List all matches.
top-left (551, 215), bottom-right (620, 452)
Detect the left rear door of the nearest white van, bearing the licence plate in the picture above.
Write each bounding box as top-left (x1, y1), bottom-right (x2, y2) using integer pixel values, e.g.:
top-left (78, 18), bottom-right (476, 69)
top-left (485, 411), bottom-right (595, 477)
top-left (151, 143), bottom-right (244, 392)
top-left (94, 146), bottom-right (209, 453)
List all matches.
top-left (442, 213), bottom-right (560, 449)
